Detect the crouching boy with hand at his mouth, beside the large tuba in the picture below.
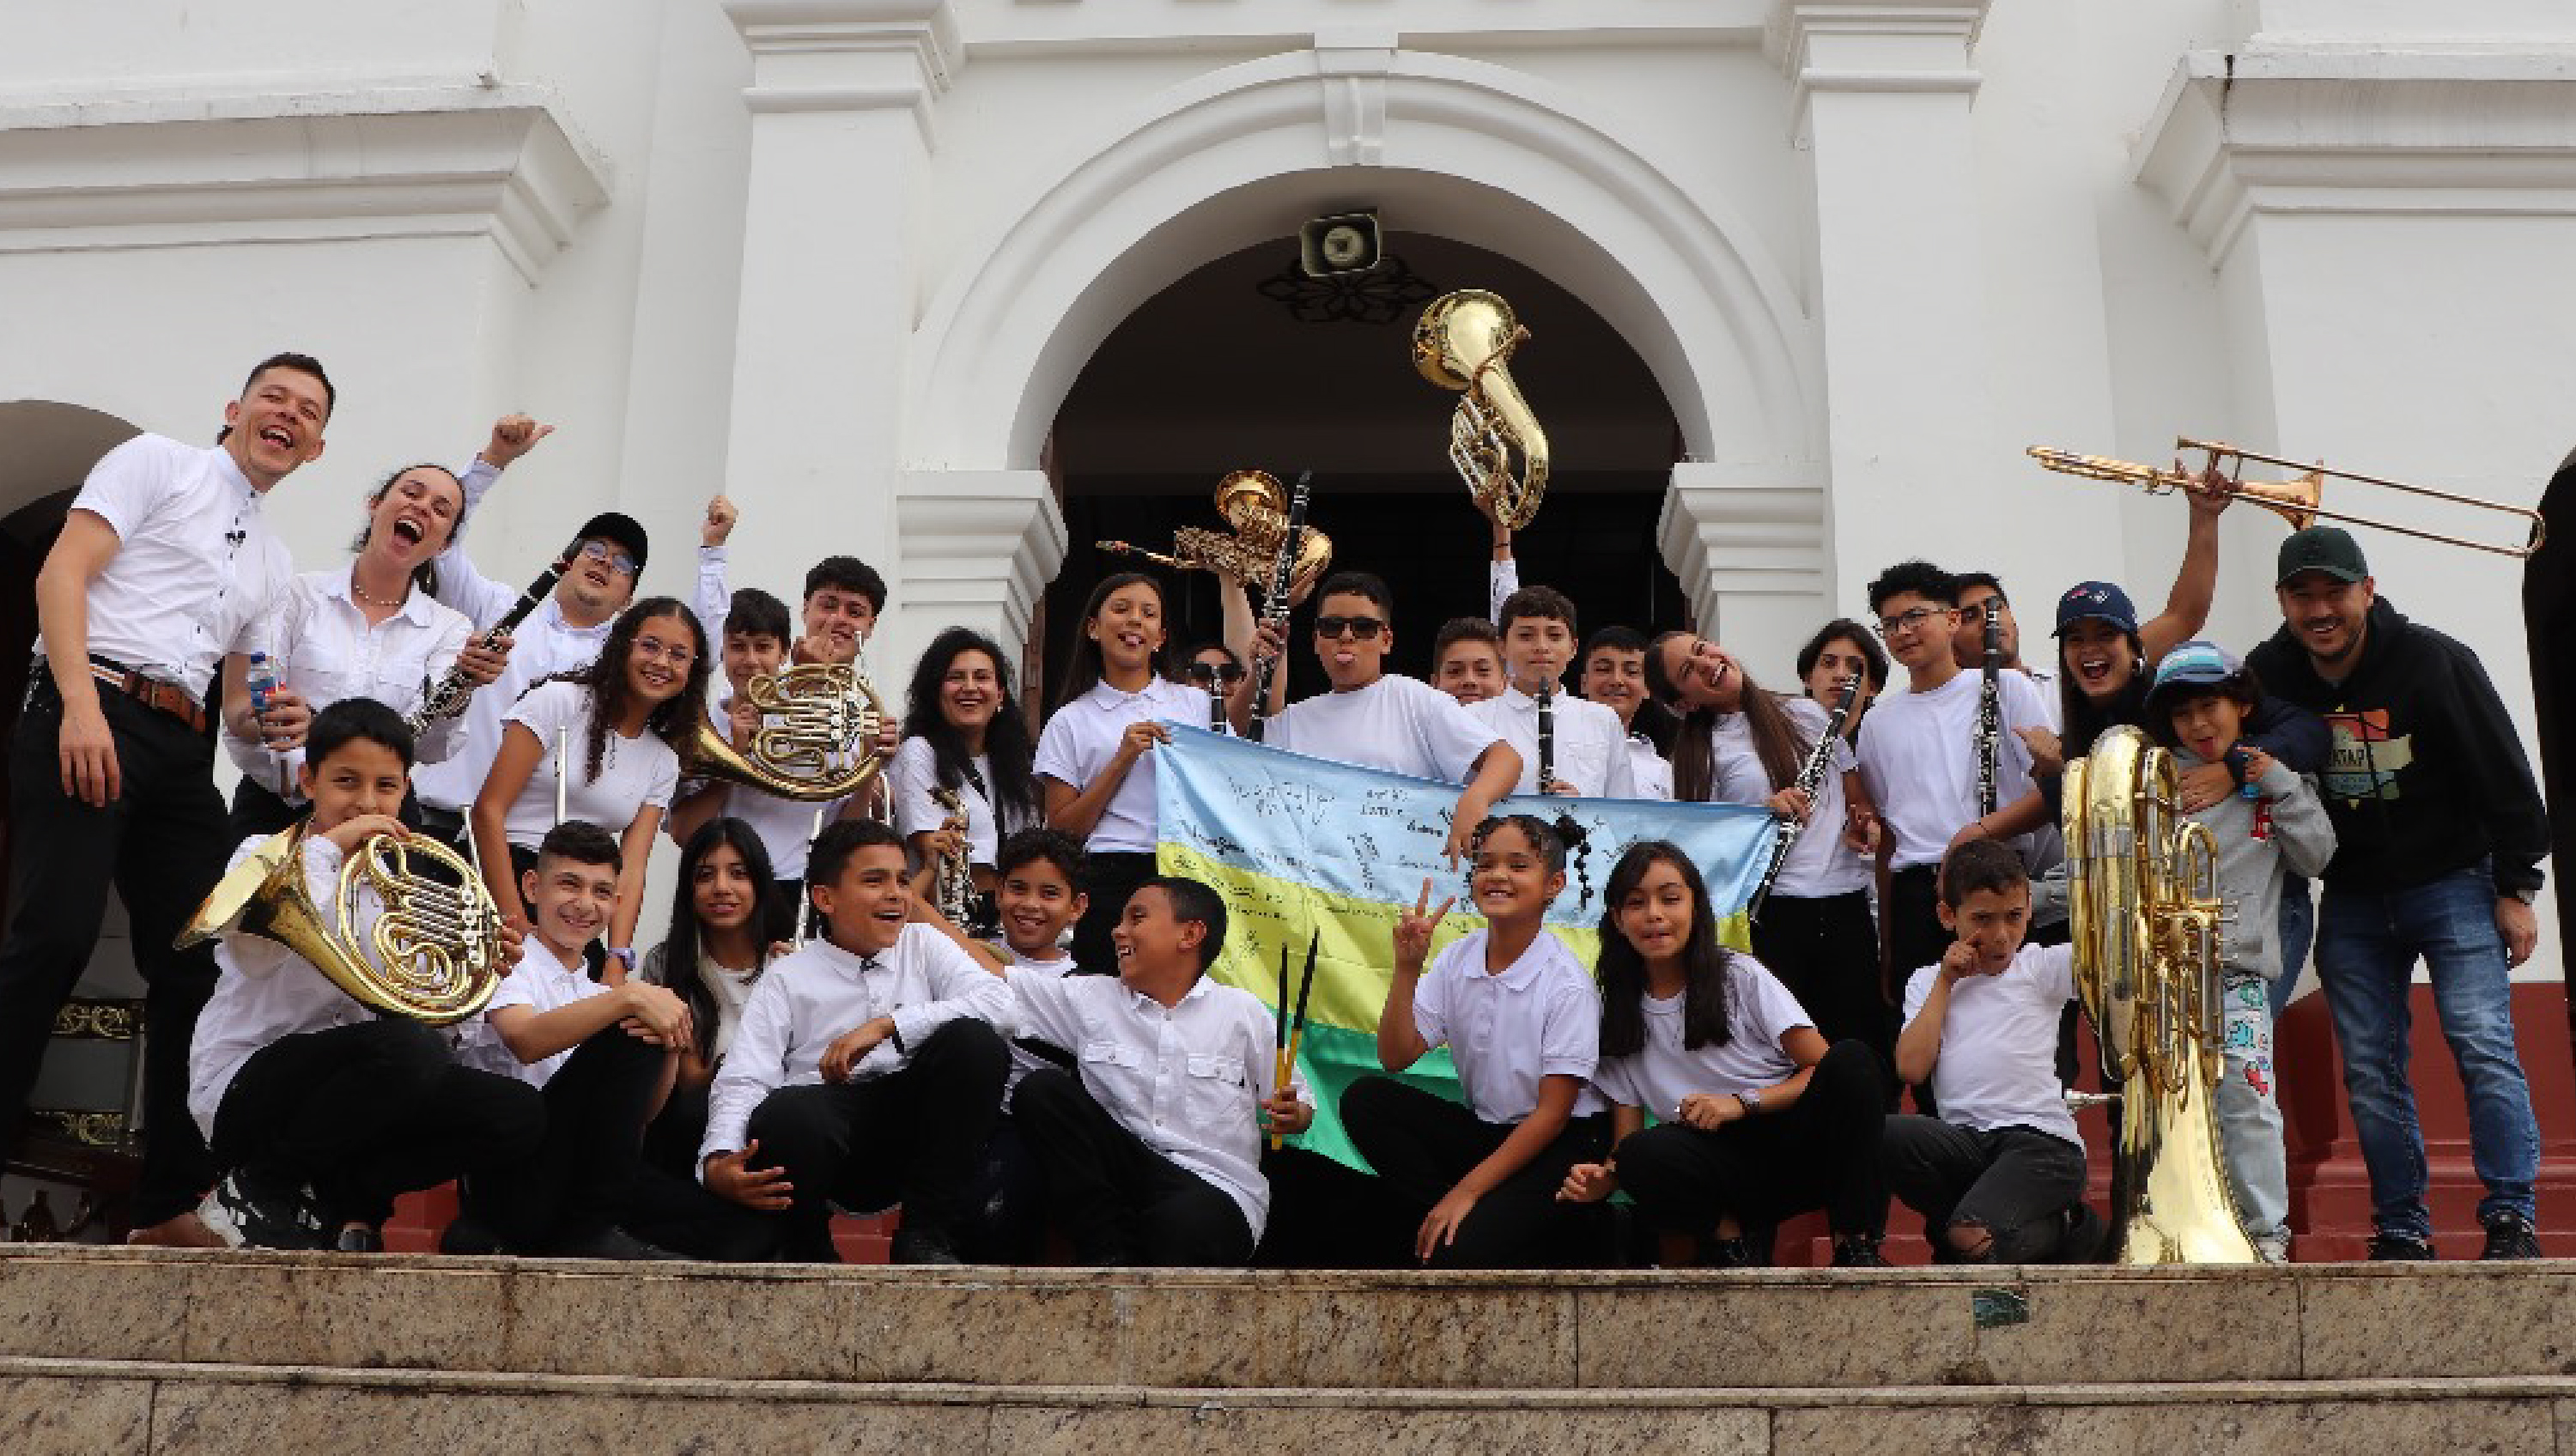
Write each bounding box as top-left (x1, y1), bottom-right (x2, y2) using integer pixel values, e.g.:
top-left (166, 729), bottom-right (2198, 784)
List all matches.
top-left (1873, 840), bottom-right (2102, 1263)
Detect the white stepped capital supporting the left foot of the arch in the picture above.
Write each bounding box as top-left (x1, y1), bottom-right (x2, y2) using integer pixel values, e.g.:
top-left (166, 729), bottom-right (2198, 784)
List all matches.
top-left (894, 469), bottom-right (1066, 662)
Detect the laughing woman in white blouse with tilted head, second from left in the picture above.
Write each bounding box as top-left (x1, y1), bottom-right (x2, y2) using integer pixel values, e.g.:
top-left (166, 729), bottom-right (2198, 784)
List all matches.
top-left (224, 464), bottom-right (507, 840)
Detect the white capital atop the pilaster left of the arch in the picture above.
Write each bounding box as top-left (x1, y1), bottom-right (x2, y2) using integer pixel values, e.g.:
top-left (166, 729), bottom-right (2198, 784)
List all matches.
top-left (724, 0), bottom-right (966, 142)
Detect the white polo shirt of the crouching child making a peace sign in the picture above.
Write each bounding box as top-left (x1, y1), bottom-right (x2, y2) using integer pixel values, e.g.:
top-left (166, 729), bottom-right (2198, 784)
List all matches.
top-left (1414, 931), bottom-right (1602, 1124)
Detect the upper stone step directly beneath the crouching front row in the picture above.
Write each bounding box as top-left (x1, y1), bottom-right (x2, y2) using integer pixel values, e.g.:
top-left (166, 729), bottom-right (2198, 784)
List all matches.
top-left (0, 1245), bottom-right (2576, 1391)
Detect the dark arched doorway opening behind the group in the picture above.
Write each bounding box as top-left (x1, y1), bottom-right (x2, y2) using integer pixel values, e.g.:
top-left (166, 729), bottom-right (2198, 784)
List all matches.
top-left (1043, 232), bottom-right (1687, 695)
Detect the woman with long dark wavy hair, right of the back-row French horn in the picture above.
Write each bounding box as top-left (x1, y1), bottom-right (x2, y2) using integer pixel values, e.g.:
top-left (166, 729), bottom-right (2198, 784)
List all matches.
top-left (886, 626), bottom-right (1043, 925)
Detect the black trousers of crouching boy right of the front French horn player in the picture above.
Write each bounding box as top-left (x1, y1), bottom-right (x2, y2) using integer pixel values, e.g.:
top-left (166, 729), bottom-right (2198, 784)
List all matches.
top-left (466, 1026), bottom-right (670, 1253)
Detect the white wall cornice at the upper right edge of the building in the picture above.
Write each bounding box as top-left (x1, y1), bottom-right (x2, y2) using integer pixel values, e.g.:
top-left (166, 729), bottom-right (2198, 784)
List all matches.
top-left (2136, 46), bottom-right (2576, 268)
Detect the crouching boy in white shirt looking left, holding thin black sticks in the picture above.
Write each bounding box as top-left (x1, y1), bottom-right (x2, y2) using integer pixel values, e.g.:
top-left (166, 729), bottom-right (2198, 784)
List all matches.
top-left (1010, 874), bottom-right (1314, 1265)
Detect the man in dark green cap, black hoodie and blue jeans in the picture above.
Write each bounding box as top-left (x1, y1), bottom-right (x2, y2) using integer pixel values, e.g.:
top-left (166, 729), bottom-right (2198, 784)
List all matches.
top-left (2249, 525), bottom-right (2550, 1260)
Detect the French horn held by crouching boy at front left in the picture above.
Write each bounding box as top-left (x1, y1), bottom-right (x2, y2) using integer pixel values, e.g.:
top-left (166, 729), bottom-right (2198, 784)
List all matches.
top-left (178, 825), bottom-right (507, 1026)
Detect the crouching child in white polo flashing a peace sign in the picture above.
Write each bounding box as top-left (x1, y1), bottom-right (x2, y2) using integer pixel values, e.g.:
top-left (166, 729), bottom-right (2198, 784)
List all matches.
top-left (1342, 815), bottom-right (1610, 1268)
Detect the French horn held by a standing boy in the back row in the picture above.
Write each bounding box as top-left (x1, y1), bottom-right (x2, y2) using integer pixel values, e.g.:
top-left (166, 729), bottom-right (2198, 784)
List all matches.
top-left (683, 662), bottom-right (886, 804)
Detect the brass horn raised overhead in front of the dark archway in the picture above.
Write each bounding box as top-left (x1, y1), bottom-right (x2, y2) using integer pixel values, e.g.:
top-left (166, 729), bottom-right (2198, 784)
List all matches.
top-left (1414, 288), bottom-right (1548, 531)
